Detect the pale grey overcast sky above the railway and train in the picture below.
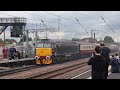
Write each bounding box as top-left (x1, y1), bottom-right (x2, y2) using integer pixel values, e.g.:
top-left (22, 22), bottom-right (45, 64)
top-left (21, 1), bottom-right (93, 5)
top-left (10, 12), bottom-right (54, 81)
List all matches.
top-left (0, 11), bottom-right (120, 42)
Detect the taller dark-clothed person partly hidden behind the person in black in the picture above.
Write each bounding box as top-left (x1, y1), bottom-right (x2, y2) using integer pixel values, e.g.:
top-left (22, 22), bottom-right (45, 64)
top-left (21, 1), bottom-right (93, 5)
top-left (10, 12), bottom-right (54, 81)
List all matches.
top-left (100, 43), bottom-right (110, 79)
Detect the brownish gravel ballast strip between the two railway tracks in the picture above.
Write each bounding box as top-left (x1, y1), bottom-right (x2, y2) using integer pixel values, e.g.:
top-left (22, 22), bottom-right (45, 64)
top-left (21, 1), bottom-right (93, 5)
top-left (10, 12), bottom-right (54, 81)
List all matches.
top-left (0, 58), bottom-right (88, 79)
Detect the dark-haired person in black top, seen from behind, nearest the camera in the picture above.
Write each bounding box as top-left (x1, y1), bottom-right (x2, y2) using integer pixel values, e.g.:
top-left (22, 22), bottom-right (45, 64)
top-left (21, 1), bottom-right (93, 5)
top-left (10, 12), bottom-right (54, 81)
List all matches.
top-left (88, 46), bottom-right (106, 79)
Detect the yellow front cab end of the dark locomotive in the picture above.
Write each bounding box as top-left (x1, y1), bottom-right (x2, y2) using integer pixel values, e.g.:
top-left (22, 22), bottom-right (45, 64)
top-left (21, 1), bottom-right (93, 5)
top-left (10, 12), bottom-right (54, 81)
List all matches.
top-left (35, 42), bottom-right (52, 64)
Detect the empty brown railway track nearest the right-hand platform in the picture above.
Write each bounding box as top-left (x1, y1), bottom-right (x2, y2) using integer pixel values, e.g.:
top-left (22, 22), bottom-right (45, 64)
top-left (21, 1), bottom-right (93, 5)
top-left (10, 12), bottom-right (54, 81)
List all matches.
top-left (26, 62), bottom-right (87, 79)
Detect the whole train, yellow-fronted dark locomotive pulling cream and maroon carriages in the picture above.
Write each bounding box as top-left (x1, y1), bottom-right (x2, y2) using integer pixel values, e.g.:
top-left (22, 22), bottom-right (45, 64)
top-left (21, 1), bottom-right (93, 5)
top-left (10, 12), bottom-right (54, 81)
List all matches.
top-left (35, 39), bottom-right (119, 65)
